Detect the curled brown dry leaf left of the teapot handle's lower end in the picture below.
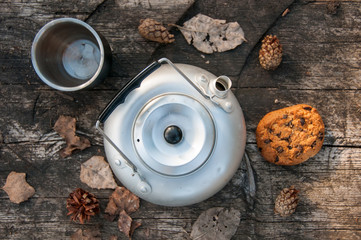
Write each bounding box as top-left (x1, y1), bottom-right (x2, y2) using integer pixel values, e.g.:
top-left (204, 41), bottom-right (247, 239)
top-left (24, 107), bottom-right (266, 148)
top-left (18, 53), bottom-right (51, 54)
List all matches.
top-left (54, 116), bottom-right (90, 158)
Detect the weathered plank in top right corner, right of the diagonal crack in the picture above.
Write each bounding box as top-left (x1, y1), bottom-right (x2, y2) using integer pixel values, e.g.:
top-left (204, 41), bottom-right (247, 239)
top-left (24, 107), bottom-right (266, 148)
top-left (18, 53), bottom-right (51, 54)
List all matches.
top-left (238, 1), bottom-right (361, 90)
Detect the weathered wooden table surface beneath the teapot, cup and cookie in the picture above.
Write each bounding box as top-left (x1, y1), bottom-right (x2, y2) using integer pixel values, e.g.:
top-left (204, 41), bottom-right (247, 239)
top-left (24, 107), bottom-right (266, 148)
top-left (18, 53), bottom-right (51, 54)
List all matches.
top-left (0, 0), bottom-right (361, 239)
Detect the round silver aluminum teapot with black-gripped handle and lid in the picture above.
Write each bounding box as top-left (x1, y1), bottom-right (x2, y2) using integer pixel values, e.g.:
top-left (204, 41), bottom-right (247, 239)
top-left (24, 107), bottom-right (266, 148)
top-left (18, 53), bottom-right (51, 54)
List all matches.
top-left (96, 58), bottom-right (246, 206)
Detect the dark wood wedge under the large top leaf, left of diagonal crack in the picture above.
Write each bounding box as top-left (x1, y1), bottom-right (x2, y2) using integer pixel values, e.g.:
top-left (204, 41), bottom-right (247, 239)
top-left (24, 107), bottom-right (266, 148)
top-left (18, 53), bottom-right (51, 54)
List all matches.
top-left (152, 0), bottom-right (293, 76)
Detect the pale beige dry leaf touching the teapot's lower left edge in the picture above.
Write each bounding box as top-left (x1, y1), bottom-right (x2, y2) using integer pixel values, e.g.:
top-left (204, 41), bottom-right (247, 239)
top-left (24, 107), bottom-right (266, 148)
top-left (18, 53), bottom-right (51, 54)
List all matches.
top-left (80, 156), bottom-right (117, 189)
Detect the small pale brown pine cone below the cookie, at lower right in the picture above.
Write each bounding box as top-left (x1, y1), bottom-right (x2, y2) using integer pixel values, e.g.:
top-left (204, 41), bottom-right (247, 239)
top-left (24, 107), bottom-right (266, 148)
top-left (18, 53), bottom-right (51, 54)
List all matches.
top-left (274, 186), bottom-right (299, 217)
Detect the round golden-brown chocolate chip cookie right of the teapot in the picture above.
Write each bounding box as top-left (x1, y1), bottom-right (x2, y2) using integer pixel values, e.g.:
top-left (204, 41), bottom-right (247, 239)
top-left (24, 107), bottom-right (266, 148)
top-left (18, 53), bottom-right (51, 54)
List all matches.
top-left (256, 104), bottom-right (325, 165)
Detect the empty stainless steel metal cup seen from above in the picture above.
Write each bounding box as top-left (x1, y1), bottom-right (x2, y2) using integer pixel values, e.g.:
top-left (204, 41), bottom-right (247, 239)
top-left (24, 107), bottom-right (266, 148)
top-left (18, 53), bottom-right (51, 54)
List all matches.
top-left (31, 18), bottom-right (111, 91)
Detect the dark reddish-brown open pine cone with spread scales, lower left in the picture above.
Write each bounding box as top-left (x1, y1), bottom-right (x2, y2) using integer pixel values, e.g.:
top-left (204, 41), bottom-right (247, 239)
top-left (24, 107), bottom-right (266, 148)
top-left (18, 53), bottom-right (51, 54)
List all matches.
top-left (66, 188), bottom-right (100, 224)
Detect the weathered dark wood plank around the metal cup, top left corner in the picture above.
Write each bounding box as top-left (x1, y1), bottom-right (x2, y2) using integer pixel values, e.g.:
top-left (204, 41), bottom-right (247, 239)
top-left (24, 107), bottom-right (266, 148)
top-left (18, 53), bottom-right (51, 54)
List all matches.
top-left (0, 0), bottom-right (194, 89)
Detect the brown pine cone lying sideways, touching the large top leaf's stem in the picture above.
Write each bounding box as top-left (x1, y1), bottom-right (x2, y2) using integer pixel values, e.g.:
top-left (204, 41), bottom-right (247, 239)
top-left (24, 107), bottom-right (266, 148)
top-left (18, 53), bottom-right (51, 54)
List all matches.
top-left (138, 18), bottom-right (174, 43)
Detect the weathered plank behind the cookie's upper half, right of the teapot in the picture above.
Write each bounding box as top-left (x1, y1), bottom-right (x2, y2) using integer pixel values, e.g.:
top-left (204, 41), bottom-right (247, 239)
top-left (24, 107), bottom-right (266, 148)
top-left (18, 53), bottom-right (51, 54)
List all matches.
top-left (237, 88), bottom-right (361, 146)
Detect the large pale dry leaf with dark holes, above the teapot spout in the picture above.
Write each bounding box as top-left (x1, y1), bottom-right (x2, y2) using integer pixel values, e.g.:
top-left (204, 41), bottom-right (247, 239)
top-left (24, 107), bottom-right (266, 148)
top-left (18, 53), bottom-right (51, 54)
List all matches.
top-left (179, 13), bottom-right (245, 54)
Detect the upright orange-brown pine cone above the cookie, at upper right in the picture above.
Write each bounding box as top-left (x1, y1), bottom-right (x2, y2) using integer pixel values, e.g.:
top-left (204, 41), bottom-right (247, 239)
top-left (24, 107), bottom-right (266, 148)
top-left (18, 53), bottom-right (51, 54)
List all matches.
top-left (259, 35), bottom-right (282, 70)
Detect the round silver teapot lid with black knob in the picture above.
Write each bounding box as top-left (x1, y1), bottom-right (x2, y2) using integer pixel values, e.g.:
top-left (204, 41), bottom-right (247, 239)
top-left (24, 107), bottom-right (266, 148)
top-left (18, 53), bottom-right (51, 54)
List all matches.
top-left (132, 93), bottom-right (216, 176)
